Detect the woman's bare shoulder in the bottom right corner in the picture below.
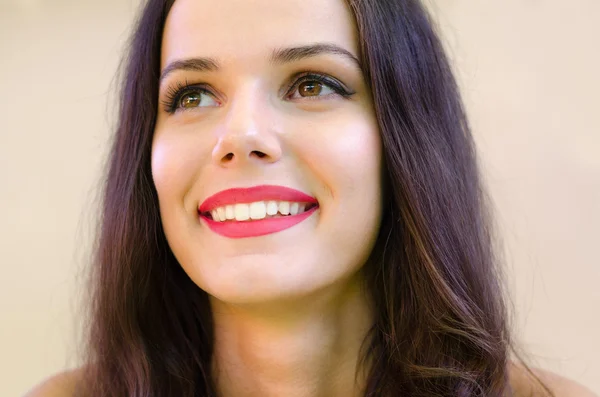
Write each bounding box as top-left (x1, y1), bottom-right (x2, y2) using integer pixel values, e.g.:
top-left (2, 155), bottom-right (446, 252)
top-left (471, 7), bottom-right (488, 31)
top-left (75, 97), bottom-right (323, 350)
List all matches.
top-left (509, 363), bottom-right (599, 397)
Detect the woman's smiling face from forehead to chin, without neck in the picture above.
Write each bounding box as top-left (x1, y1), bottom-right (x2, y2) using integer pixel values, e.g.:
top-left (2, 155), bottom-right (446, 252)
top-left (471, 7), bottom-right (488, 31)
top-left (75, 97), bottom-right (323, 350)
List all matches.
top-left (152, 0), bottom-right (382, 303)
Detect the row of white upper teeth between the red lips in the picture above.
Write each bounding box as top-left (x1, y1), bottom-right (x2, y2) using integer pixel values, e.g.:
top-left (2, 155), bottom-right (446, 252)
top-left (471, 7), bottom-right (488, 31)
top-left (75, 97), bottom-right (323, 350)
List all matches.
top-left (211, 200), bottom-right (314, 222)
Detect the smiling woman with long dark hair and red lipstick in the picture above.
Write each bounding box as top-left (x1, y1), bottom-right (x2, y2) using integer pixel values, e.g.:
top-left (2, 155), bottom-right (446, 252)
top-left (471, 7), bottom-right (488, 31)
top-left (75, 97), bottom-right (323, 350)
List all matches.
top-left (25, 0), bottom-right (590, 397)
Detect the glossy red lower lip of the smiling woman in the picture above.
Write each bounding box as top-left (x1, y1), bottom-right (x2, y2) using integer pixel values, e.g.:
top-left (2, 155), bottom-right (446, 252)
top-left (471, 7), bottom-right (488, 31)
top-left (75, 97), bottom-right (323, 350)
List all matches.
top-left (200, 207), bottom-right (319, 238)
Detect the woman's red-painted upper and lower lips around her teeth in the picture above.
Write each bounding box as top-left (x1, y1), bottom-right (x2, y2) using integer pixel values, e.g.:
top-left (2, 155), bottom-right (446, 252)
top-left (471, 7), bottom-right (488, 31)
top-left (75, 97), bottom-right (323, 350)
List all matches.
top-left (198, 185), bottom-right (319, 238)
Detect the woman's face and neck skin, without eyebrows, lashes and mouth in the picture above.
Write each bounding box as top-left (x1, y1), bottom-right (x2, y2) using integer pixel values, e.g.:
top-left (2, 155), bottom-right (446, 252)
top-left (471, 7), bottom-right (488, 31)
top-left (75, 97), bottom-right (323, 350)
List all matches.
top-left (152, 0), bottom-right (382, 397)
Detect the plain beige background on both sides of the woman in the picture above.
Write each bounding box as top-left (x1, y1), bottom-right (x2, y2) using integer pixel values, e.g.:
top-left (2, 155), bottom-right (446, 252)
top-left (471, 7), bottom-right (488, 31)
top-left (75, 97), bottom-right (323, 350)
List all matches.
top-left (0, 0), bottom-right (600, 396)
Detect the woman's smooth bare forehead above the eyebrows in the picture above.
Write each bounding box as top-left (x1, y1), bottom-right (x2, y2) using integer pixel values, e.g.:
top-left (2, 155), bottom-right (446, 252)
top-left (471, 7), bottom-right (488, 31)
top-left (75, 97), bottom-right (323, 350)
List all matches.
top-left (161, 0), bottom-right (358, 68)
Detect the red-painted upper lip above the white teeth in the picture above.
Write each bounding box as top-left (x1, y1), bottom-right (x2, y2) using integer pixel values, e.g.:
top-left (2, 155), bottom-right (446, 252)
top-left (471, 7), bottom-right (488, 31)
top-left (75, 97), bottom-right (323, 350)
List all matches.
top-left (198, 185), bottom-right (318, 213)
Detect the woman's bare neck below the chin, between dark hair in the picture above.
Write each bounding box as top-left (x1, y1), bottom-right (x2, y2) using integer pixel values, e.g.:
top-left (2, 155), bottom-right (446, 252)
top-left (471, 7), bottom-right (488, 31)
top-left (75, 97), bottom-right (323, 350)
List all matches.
top-left (211, 274), bottom-right (372, 397)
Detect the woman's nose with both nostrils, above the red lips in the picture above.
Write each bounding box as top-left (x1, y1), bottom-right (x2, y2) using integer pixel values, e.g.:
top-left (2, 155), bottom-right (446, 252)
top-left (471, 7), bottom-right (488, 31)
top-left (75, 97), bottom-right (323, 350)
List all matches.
top-left (212, 87), bottom-right (282, 167)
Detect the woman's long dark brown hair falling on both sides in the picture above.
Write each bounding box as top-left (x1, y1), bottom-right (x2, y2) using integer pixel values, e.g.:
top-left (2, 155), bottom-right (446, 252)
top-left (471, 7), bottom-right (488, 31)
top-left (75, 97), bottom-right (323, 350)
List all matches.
top-left (78, 0), bottom-right (552, 397)
